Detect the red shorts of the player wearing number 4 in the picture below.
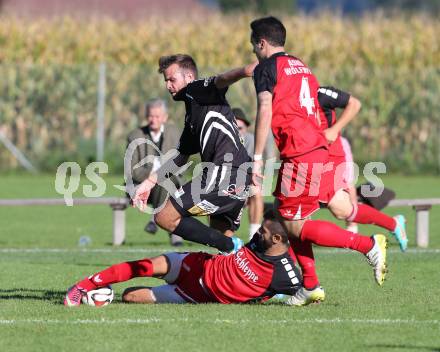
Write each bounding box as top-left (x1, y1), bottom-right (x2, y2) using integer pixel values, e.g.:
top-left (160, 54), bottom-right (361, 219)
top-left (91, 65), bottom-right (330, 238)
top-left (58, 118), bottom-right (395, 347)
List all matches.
top-left (273, 148), bottom-right (328, 220)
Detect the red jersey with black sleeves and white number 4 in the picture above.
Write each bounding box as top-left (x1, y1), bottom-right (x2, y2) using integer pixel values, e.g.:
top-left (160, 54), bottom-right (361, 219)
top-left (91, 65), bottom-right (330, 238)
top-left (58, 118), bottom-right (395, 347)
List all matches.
top-left (254, 52), bottom-right (327, 159)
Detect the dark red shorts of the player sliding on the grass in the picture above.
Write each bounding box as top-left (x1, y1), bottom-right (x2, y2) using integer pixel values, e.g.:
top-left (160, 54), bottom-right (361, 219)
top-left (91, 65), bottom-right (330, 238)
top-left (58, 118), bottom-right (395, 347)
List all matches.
top-left (174, 252), bottom-right (217, 303)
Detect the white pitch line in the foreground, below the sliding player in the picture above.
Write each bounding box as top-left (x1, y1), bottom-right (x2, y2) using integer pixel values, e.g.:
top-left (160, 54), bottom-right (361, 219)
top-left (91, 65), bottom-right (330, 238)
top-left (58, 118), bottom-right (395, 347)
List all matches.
top-left (0, 318), bottom-right (440, 325)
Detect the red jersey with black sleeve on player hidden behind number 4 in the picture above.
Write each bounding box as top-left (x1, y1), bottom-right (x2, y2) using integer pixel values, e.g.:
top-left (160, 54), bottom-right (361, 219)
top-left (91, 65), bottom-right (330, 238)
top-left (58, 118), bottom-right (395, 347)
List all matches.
top-left (318, 87), bottom-right (350, 156)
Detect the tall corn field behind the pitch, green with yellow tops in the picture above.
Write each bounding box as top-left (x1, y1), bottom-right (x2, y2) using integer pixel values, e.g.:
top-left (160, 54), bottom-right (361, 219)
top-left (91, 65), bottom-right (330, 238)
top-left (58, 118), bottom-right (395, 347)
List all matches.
top-left (0, 14), bottom-right (440, 173)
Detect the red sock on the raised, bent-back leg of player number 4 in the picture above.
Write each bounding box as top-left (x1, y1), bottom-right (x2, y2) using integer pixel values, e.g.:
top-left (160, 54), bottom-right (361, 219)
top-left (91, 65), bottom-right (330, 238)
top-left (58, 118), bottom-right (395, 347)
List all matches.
top-left (295, 220), bottom-right (374, 254)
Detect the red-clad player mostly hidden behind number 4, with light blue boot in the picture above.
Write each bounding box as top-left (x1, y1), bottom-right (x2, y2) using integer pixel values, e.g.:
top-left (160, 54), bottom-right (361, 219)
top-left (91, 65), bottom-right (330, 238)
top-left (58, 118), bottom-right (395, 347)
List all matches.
top-left (318, 87), bottom-right (408, 251)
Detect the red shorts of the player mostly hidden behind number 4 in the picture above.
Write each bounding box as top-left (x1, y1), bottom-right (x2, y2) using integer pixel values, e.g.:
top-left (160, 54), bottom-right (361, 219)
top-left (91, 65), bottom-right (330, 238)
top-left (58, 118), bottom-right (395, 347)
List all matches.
top-left (319, 155), bottom-right (350, 203)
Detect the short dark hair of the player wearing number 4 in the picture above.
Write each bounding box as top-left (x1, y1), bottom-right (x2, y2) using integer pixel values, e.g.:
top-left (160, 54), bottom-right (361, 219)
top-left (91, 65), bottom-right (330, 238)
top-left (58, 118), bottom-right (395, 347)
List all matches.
top-left (251, 16), bottom-right (286, 46)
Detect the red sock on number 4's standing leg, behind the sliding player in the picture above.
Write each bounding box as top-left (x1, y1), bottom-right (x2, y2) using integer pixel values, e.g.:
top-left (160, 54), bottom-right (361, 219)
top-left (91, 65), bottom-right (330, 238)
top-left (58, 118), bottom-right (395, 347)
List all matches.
top-left (289, 238), bottom-right (319, 290)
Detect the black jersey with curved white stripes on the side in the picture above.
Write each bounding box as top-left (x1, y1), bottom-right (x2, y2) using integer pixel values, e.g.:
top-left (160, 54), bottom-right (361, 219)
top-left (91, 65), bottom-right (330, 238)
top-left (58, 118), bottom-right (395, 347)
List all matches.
top-left (174, 77), bottom-right (251, 167)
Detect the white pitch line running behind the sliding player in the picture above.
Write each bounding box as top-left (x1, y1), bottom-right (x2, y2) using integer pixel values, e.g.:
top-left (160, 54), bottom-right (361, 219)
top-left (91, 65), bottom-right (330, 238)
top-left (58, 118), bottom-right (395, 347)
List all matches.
top-left (0, 247), bottom-right (440, 255)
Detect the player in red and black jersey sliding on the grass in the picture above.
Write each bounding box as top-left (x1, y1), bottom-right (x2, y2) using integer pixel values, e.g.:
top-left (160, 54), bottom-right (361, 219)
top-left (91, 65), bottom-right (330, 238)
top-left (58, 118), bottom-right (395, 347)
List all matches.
top-left (64, 219), bottom-right (302, 306)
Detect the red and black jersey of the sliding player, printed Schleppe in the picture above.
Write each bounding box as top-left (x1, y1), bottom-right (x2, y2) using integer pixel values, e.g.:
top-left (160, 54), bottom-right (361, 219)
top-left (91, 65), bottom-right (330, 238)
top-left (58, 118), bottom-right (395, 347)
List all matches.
top-left (202, 236), bottom-right (301, 304)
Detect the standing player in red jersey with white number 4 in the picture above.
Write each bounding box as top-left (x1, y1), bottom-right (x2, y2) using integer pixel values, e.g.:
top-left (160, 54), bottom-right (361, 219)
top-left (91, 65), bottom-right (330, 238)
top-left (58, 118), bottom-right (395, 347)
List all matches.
top-left (251, 17), bottom-right (386, 305)
